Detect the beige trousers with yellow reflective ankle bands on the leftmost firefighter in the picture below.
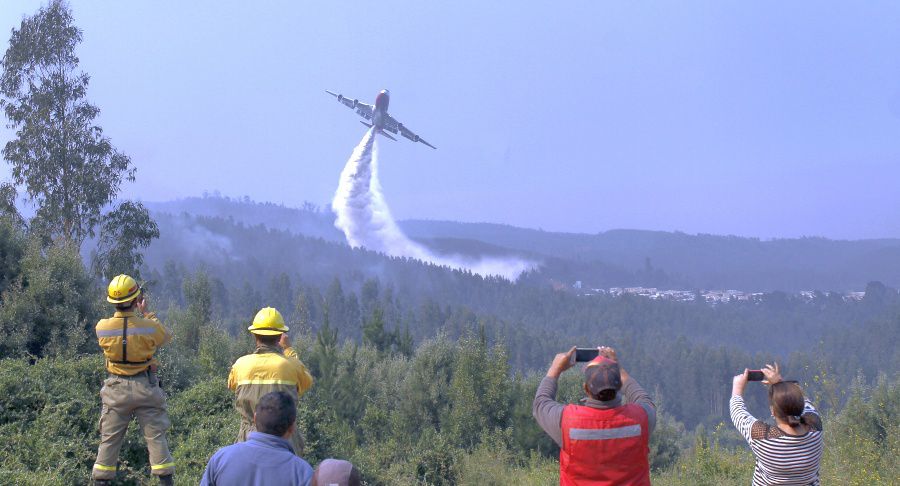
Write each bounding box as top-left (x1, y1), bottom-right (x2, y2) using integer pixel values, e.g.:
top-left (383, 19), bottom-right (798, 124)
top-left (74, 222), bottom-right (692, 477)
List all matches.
top-left (91, 372), bottom-right (175, 479)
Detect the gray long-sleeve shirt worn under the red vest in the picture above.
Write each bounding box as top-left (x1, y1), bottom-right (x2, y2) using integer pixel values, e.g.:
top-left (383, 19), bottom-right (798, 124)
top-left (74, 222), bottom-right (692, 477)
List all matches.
top-left (531, 376), bottom-right (656, 447)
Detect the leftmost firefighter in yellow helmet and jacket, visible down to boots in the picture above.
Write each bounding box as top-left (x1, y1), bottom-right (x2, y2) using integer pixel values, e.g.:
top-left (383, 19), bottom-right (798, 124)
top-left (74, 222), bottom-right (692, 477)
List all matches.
top-left (91, 275), bottom-right (175, 485)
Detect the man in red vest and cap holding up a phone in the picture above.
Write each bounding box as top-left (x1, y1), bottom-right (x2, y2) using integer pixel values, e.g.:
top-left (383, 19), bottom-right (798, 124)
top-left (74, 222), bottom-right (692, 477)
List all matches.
top-left (532, 346), bottom-right (656, 486)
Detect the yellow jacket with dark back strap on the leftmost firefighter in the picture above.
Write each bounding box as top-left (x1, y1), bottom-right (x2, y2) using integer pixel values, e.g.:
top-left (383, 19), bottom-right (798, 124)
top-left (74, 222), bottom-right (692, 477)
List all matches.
top-left (96, 311), bottom-right (172, 376)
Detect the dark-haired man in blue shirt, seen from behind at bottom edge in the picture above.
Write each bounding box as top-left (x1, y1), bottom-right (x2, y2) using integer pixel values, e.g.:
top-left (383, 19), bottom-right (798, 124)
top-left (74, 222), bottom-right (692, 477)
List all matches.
top-left (200, 391), bottom-right (313, 486)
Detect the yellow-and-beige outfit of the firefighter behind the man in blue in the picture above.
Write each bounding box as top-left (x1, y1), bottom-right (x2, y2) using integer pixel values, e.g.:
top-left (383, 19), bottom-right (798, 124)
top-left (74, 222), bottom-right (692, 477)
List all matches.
top-left (228, 346), bottom-right (312, 455)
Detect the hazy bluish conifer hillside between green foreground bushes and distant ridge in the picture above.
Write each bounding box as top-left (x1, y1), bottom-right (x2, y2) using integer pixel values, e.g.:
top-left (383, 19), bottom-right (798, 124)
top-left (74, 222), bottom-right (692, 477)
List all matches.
top-left (135, 211), bottom-right (900, 427)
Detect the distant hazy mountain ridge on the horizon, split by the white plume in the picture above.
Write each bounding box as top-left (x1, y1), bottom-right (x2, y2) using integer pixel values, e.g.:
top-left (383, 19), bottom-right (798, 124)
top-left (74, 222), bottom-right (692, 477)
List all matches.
top-left (147, 196), bottom-right (900, 291)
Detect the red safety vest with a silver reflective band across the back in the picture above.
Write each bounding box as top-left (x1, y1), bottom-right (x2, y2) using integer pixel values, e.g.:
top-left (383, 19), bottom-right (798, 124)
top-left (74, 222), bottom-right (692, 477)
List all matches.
top-left (559, 404), bottom-right (650, 486)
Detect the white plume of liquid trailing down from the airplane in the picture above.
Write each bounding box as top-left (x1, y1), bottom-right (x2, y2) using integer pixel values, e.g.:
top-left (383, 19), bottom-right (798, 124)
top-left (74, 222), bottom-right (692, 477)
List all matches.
top-left (331, 129), bottom-right (535, 281)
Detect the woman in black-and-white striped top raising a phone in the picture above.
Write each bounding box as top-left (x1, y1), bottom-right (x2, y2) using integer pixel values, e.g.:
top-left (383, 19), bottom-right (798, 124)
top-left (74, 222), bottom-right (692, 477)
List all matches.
top-left (731, 363), bottom-right (823, 486)
